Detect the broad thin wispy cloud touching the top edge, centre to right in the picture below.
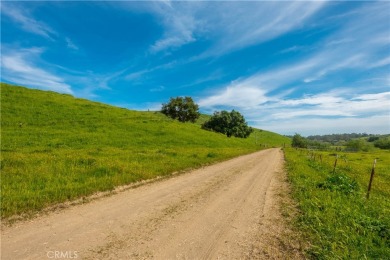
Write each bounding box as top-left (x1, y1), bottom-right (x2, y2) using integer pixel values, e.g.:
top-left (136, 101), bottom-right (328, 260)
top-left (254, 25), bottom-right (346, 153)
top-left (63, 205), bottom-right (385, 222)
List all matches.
top-left (145, 2), bottom-right (325, 55)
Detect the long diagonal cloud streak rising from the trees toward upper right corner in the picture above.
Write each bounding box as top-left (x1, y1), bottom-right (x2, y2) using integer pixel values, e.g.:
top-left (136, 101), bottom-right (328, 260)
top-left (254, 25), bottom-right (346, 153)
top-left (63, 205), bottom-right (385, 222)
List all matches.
top-left (201, 1), bottom-right (390, 107)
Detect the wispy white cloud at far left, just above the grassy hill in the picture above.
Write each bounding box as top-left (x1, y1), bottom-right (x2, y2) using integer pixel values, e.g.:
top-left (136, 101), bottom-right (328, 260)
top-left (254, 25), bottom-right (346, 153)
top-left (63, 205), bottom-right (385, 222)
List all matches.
top-left (1, 48), bottom-right (73, 94)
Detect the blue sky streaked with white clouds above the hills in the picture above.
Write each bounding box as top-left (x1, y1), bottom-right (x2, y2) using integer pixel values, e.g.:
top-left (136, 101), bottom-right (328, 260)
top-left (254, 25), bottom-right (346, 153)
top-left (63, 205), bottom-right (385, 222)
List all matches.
top-left (1, 1), bottom-right (390, 135)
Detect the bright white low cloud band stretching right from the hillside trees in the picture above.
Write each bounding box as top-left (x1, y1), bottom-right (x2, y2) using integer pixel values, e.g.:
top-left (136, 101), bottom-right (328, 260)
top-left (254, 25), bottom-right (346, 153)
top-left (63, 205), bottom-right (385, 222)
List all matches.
top-left (199, 87), bottom-right (390, 122)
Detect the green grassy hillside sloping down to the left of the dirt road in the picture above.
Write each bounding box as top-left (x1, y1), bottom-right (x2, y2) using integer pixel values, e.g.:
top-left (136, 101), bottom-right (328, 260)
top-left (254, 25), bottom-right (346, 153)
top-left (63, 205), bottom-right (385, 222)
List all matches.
top-left (1, 83), bottom-right (290, 217)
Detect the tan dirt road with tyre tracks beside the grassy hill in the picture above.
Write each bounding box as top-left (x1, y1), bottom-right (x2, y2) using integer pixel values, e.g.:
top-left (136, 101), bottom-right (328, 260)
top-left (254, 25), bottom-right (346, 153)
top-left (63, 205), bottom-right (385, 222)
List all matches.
top-left (1, 149), bottom-right (302, 260)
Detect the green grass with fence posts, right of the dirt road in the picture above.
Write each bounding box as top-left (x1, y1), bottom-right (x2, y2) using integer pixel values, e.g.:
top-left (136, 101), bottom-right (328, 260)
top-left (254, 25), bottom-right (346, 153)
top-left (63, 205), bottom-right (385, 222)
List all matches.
top-left (285, 148), bottom-right (390, 259)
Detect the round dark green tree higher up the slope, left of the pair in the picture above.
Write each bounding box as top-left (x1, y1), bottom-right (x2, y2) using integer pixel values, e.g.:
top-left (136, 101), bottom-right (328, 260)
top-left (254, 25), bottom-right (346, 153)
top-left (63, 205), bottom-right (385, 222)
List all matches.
top-left (161, 97), bottom-right (200, 123)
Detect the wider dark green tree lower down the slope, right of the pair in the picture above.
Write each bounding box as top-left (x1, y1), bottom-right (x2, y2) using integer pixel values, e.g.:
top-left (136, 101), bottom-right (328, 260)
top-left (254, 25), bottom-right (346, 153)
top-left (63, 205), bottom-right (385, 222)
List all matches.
top-left (202, 110), bottom-right (253, 138)
